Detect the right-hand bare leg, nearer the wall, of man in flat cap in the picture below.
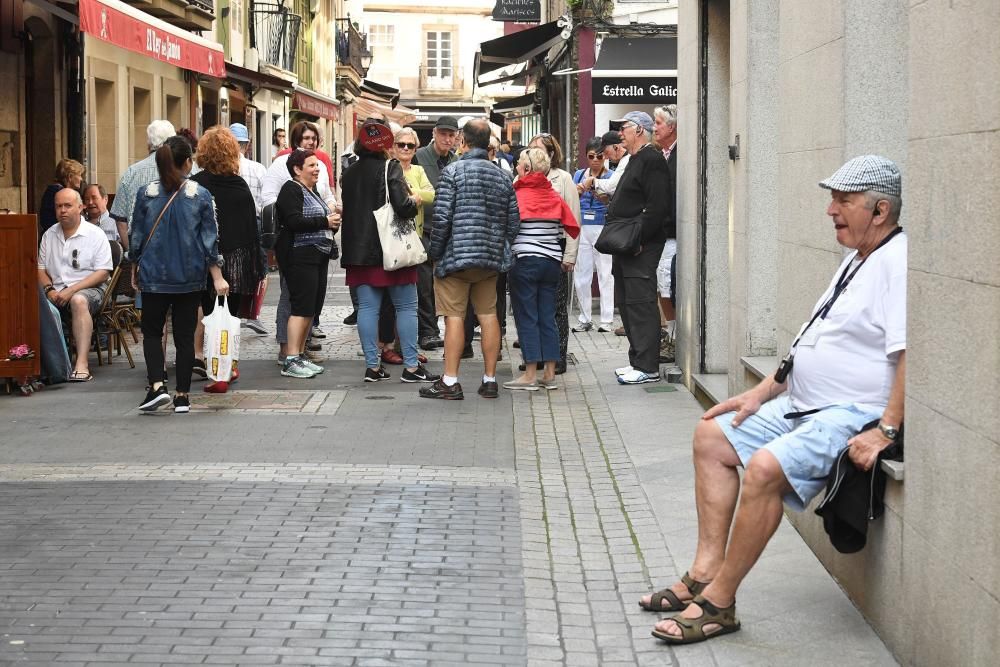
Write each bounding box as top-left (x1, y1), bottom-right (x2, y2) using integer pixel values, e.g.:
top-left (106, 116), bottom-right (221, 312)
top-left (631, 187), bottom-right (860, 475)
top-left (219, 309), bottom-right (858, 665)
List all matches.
top-left (656, 450), bottom-right (791, 637)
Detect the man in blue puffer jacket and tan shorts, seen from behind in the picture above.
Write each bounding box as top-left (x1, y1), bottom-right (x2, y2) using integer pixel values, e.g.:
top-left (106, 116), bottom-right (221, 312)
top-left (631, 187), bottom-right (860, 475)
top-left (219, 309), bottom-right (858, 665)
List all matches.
top-left (420, 119), bottom-right (521, 400)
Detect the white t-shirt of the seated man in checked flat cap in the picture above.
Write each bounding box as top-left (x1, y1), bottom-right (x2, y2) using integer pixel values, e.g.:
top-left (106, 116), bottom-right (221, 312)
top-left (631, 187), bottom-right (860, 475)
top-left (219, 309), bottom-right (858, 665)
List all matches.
top-left (788, 233), bottom-right (907, 410)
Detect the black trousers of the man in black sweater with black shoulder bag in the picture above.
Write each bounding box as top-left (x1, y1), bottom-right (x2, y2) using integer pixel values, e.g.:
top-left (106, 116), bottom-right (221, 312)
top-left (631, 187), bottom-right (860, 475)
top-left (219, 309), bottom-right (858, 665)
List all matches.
top-left (611, 243), bottom-right (663, 374)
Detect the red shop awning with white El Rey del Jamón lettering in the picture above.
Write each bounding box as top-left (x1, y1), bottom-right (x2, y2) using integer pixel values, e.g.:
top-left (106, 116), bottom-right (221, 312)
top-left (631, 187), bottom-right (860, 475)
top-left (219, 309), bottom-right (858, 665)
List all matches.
top-left (80, 0), bottom-right (226, 79)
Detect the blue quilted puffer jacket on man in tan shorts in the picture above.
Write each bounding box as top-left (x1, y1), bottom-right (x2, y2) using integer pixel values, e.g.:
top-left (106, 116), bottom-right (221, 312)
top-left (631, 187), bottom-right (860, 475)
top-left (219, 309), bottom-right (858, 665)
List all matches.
top-left (427, 148), bottom-right (521, 278)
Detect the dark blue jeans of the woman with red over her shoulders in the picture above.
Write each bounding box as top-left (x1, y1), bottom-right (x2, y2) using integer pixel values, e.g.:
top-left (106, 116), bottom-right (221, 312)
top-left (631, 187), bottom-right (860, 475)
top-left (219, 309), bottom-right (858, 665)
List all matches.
top-left (507, 256), bottom-right (561, 363)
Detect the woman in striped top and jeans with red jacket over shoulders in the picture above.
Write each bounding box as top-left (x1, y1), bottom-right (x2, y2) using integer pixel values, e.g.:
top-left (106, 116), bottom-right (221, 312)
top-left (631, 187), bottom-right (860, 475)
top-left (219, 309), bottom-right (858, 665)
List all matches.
top-left (504, 148), bottom-right (580, 391)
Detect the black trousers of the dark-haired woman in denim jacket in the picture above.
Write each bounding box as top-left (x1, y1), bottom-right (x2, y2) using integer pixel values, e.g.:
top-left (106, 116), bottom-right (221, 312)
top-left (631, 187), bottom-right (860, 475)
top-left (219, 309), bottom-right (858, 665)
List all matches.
top-left (141, 292), bottom-right (202, 394)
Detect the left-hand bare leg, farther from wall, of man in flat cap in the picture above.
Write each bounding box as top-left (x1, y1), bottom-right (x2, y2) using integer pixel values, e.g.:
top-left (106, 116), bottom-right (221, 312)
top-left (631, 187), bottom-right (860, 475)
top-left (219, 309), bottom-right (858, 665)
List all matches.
top-left (642, 419), bottom-right (740, 605)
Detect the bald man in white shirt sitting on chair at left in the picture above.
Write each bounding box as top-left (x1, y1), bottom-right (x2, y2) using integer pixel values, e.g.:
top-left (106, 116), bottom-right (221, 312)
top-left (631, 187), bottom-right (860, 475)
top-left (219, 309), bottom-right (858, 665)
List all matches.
top-left (38, 188), bottom-right (112, 382)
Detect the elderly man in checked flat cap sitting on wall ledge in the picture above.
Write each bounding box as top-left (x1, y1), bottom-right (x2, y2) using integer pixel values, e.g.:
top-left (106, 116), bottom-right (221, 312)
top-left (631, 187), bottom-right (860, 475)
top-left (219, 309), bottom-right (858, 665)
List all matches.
top-left (639, 155), bottom-right (907, 644)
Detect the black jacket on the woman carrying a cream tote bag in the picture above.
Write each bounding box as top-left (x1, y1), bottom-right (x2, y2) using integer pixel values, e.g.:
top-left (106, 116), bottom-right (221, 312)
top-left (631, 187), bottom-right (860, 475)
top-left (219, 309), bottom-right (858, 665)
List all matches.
top-left (340, 153), bottom-right (417, 266)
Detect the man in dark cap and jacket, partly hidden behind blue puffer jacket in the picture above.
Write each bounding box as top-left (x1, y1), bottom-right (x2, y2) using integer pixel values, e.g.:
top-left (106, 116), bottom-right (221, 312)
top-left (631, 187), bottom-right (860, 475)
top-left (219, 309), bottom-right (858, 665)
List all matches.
top-left (413, 116), bottom-right (458, 350)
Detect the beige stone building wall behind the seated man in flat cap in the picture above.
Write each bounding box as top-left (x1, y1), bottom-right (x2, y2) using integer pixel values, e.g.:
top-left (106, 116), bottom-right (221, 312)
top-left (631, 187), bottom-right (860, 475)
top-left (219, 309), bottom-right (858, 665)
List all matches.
top-left (678, 0), bottom-right (1000, 665)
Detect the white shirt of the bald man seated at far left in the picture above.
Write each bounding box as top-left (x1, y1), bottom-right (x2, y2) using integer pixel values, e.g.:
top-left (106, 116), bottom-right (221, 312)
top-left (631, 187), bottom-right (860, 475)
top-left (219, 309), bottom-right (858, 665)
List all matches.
top-left (38, 219), bottom-right (112, 290)
